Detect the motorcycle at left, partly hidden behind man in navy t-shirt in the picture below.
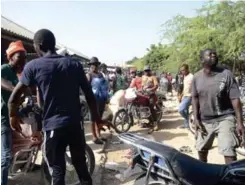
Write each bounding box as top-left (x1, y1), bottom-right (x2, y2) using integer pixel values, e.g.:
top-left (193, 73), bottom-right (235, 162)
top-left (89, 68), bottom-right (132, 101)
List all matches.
top-left (9, 98), bottom-right (95, 185)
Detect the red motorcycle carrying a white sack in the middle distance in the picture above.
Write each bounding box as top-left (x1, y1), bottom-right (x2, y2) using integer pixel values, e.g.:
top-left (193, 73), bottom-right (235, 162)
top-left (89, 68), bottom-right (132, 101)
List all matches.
top-left (112, 88), bottom-right (163, 133)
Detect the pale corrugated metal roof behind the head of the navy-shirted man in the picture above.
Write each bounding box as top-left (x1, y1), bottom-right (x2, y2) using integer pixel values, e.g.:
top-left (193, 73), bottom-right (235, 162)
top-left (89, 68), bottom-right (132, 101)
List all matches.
top-left (1, 15), bottom-right (89, 59)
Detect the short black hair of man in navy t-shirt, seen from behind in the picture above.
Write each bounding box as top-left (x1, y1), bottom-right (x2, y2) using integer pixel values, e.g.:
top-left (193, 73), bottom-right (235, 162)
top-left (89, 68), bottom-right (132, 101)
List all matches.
top-left (33, 29), bottom-right (56, 51)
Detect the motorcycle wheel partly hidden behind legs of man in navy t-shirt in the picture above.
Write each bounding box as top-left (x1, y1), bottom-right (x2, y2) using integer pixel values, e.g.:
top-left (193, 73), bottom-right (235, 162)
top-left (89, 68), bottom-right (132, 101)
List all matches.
top-left (42, 145), bottom-right (95, 185)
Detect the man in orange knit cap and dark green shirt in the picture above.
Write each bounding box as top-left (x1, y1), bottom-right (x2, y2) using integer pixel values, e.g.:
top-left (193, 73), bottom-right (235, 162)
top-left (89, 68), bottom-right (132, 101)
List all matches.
top-left (1, 41), bottom-right (26, 185)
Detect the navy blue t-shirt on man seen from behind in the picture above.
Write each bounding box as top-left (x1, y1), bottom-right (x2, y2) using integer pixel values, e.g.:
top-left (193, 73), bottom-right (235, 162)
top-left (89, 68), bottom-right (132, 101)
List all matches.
top-left (20, 54), bottom-right (91, 131)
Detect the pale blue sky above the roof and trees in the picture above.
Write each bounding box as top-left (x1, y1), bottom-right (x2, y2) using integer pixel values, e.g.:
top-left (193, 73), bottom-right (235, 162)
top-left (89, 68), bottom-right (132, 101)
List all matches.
top-left (1, 0), bottom-right (204, 64)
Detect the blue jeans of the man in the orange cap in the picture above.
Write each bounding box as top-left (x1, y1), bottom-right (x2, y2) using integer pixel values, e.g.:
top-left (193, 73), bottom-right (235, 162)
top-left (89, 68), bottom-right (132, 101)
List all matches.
top-left (1, 125), bottom-right (12, 185)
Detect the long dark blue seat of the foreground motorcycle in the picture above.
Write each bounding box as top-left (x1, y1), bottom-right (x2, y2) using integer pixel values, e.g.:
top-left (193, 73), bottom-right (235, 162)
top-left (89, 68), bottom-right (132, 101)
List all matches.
top-left (138, 140), bottom-right (227, 185)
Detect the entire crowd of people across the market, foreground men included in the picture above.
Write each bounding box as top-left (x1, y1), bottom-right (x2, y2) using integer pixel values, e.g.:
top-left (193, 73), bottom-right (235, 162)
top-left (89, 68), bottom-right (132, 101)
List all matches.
top-left (1, 29), bottom-right (245, 185)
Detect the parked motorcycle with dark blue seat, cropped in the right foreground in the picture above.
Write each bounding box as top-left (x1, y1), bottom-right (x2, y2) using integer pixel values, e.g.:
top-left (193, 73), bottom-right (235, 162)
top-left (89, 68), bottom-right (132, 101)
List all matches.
top-left (118, 133), bottom-right (245, 185)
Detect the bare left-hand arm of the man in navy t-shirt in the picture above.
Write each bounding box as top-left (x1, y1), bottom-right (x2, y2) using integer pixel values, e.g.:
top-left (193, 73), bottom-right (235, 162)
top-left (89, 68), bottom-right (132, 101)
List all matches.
top-left (8, 82), bottom-right (28, 117)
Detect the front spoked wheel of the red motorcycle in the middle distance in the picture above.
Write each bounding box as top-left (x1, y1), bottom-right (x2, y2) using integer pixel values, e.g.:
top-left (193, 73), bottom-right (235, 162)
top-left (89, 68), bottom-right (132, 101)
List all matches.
top-left (112, 109), bottom-right (134, 134)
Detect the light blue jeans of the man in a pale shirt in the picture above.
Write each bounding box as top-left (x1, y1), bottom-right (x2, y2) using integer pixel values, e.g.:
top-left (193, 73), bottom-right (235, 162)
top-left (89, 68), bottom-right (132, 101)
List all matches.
top-left (179, 96), bottom-right (191, 128)
